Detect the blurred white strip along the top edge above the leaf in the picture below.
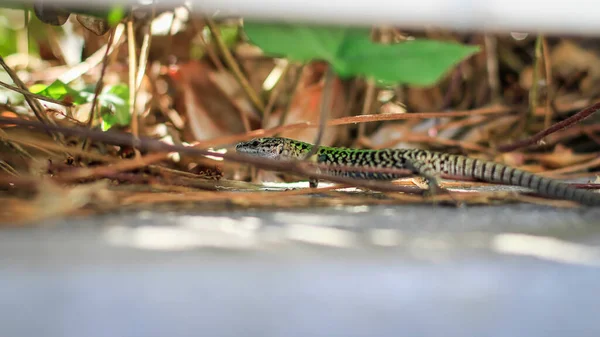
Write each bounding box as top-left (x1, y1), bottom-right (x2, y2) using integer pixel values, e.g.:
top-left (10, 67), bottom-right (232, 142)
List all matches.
top-left (18, 0), bottom-right (600, 34)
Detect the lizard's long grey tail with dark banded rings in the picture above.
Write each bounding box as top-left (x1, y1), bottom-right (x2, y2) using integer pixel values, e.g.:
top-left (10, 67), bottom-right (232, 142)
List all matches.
top-left (444, 155), bottom-right (600, 206)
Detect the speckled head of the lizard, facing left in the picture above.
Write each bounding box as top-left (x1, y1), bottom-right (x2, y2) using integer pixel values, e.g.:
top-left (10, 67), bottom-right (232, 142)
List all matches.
top-left (235, 137), bottom-right (310, 160)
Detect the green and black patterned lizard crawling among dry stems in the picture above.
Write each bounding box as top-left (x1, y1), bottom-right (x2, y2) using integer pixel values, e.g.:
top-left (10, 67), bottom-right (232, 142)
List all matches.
top-left (236, 137), bottom-right (600, 206)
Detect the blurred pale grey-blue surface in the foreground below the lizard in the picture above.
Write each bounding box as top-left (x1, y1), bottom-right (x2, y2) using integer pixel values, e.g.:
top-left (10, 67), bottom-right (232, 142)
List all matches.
top-left (0, 197), bottom-right (600, 337)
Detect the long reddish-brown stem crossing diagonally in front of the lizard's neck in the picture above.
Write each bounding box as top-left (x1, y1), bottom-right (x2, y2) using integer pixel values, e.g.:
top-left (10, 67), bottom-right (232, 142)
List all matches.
top-left (0, 117), bottom-right (422, 193)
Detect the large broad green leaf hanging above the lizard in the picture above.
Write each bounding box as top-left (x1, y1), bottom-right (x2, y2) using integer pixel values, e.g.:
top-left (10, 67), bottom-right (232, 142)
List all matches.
top-left (244, 22), bottom-right (479, 86)
